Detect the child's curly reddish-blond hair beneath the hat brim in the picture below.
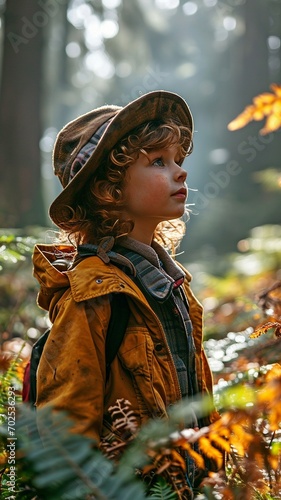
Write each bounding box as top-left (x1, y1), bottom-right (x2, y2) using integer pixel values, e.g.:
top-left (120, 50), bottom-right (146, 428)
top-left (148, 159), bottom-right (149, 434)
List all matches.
top-left (63, 119), bottom-right (193, 252)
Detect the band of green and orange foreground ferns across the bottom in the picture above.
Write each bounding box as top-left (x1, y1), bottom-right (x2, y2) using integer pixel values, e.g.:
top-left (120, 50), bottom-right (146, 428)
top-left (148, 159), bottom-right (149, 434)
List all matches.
top-left (0, 358), bottom-right (281, 500)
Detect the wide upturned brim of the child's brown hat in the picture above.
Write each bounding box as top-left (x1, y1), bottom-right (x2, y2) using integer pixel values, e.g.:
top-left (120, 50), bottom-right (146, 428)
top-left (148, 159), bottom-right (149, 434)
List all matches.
top-left (49, 90), bottom-right (193, 227)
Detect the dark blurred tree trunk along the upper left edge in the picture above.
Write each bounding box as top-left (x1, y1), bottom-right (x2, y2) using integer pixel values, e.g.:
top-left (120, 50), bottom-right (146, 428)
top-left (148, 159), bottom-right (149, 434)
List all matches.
top-left (0, 0), bottom-right (44, 228)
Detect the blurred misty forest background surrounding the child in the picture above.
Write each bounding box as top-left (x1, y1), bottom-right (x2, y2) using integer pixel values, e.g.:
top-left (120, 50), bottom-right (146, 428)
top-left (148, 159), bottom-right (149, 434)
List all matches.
top-left (0, 0), bottom-right (281, 498)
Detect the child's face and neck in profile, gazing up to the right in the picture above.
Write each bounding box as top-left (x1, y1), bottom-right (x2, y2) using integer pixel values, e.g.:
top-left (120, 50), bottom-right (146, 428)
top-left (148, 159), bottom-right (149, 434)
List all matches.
top-left (122, 145), bottom-right (187, 243)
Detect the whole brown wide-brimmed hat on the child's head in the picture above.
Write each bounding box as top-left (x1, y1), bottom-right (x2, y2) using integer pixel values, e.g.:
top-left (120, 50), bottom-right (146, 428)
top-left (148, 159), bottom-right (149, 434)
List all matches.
top-left (49, 90), bottom-right (193, 227)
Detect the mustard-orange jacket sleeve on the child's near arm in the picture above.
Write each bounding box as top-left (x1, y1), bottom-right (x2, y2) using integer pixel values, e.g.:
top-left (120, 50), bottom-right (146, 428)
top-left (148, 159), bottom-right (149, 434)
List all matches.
top-left (36, 295), bottom-right (110, 442)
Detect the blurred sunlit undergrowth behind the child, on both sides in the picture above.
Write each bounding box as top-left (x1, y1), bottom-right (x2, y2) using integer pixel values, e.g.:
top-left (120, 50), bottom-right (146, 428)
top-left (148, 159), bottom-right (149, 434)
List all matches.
top-left (0, 225), bottom-right (281, 378)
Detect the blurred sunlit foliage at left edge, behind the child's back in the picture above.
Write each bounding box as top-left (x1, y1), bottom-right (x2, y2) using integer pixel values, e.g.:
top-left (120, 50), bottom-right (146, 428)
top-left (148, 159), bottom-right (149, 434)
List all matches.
top-left (0, 227), bottom-right (48, 358)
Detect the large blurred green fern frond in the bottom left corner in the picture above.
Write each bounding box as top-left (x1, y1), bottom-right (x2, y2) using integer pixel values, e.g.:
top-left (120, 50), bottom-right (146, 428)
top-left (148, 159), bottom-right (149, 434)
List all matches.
top-left (2, 405), bottom-right (145, 500)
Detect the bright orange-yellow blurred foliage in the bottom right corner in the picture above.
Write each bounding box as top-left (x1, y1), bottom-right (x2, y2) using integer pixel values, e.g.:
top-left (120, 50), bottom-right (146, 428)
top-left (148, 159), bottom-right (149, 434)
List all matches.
top-left (201, 364), bottom-right (281, 500)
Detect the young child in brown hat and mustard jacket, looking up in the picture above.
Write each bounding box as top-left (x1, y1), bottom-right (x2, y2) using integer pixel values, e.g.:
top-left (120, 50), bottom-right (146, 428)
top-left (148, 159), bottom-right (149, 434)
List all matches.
top-left (34, 91), bottom-right (219, 496)
